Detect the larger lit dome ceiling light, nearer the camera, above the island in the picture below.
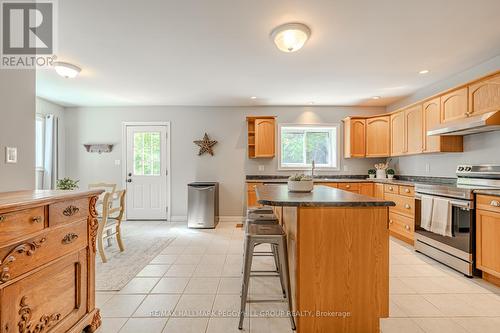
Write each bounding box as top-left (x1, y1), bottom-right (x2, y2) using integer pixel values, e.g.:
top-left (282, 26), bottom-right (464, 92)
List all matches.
top-left (271, 23), bottom-right (311, 53)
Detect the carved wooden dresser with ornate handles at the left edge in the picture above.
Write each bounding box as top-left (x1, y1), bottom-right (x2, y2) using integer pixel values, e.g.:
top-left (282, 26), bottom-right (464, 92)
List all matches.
top-left (0, 191), bottom-right (101, 333)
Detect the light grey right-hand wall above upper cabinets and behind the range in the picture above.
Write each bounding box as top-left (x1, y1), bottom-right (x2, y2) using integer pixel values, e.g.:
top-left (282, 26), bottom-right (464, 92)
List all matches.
top-left (387, 56), bottom-right (500, 177)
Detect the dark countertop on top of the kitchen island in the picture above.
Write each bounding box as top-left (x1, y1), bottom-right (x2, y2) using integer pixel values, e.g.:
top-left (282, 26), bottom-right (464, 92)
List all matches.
top-left (256, 184), bottom-right (395, 207)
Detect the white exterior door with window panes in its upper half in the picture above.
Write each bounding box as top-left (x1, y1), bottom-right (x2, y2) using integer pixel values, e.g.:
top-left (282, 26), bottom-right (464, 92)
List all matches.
top-left (125, 125), bottom-right (167, 220)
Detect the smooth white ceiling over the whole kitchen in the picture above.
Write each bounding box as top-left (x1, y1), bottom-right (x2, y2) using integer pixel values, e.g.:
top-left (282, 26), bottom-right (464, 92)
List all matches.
top-left (37, 0), bottom-right (500, 106)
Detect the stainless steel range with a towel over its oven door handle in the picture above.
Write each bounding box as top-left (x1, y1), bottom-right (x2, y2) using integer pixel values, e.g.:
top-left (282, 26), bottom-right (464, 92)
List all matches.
top-left (415, 165), bottom-right (500, 277)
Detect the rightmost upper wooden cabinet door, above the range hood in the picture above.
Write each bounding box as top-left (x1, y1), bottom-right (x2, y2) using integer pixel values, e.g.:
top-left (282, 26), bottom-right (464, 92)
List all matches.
top-left (469, 74), bottom-right (500, 116)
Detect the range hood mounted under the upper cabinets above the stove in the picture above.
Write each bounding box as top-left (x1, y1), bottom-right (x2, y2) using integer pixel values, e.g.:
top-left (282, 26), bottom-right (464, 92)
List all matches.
top-left (427, 111), bottom-right (500, 136)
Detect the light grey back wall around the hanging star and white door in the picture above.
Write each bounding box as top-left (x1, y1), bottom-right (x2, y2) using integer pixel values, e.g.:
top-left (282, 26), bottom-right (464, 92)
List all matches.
top-left (65, 106), bottom-right (385, 216)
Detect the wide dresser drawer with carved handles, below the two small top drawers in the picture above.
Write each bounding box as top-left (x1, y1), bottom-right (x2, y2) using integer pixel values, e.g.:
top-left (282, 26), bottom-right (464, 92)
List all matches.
top-left (0, 219), bottom-right (88, 285)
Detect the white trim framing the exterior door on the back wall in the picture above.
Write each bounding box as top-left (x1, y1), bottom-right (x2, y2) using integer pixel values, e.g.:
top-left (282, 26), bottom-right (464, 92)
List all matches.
top-left (121, 121), bottom-right (172, 221)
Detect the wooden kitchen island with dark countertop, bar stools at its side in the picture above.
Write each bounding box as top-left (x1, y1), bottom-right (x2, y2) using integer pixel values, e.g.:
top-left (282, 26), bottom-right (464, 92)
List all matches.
top-left (256, 185), bottom-right (395, 333)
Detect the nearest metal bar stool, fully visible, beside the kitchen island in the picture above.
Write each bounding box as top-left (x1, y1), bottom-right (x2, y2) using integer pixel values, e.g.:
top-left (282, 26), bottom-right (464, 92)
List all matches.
top-left (238, 224), bottom-right (296, 330)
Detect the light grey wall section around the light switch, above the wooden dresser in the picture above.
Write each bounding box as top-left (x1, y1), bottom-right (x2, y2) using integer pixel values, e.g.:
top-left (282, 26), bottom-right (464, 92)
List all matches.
top-left (0, 70), bottom-right (35, 192)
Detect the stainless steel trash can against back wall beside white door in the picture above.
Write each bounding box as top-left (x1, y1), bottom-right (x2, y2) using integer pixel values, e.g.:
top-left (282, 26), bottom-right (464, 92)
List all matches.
top-left (188, 182), bottom-right (219, 228)
